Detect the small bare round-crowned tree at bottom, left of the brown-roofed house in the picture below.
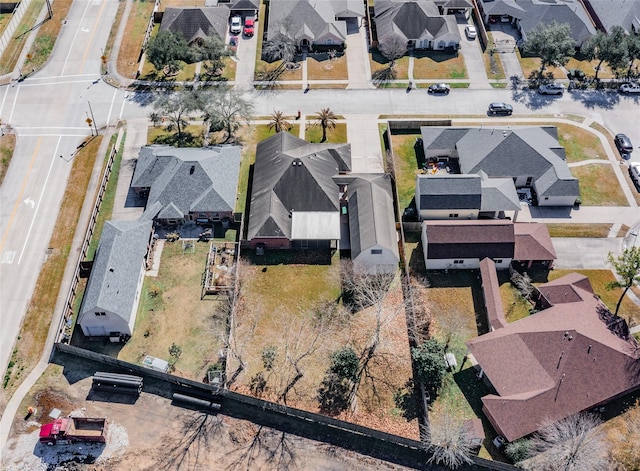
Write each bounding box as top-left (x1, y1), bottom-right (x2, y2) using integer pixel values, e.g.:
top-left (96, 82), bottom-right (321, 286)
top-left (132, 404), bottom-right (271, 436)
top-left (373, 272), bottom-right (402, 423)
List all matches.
top-left (421, 412), bottom-right (473, 469)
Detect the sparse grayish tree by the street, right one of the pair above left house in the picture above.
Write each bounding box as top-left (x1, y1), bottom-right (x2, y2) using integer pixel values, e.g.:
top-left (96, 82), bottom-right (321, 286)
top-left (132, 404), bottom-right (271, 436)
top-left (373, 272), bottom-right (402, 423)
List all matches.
top-left (201, 88), bottom-right (253, 142)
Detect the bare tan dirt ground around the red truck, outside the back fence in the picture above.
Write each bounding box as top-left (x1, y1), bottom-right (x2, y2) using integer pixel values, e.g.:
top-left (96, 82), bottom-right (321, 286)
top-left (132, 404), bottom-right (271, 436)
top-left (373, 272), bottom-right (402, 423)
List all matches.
top-left (1, 355), bottom-right (416, 471)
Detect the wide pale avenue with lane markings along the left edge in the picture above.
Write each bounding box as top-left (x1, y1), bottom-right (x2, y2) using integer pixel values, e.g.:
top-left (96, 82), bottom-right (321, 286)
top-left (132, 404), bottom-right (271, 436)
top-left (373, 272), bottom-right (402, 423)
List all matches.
top-left (0, 0), bottom-right (124, 371)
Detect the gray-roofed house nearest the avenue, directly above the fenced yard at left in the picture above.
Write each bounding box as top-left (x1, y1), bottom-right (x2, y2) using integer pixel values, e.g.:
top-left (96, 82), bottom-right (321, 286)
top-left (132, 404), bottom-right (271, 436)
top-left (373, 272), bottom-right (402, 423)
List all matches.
top-left (131, 145), bottom-right (241, 225)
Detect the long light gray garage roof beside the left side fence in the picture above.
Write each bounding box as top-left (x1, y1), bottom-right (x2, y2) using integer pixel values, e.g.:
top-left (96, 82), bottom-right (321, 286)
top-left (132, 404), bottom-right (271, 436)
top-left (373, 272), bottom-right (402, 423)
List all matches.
top-left (78, 220), bottom-right (153, 324)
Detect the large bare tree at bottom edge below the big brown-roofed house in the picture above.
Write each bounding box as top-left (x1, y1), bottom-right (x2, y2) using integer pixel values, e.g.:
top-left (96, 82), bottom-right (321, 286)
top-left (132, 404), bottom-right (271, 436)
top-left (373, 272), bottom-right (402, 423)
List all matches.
top-left (520, 413), bottom-right (611, 471)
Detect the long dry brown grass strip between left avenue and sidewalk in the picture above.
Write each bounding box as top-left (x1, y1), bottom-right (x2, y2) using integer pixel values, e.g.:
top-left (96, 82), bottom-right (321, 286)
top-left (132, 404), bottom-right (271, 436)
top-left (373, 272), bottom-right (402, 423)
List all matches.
top-left (6, 136), bottom-right (102, 394)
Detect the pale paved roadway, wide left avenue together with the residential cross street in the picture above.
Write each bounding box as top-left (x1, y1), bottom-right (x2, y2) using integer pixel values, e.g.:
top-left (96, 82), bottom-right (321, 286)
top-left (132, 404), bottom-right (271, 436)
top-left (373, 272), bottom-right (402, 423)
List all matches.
top-left (0, 0), bottom-right (640, 380)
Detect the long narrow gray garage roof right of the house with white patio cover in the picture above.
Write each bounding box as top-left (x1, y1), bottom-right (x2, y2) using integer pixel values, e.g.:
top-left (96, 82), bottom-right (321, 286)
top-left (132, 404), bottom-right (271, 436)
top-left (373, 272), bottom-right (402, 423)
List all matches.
top-left (334, 173), bottom-right (399, 259)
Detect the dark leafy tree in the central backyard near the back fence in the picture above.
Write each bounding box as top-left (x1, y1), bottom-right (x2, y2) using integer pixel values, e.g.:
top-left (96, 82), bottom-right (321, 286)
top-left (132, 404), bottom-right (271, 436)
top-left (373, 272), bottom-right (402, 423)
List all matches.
top-left (317, 347), bottom-right (360, 414)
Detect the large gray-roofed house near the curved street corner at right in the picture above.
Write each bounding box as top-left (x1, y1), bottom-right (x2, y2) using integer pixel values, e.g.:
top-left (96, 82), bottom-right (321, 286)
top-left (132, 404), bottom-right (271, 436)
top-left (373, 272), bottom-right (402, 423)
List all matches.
top-left (421, 126), bottom-right (580, 206)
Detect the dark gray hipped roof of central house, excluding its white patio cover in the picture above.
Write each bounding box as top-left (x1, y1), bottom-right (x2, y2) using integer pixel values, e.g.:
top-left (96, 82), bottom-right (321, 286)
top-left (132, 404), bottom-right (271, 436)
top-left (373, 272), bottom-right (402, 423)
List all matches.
top-left (247, 132), bottom-right (351, 240)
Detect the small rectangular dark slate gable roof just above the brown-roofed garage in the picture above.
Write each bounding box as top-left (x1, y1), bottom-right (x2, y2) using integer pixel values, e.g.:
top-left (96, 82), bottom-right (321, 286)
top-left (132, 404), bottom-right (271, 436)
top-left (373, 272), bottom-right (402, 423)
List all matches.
top-left (416, 175), bottom-right (481, 210)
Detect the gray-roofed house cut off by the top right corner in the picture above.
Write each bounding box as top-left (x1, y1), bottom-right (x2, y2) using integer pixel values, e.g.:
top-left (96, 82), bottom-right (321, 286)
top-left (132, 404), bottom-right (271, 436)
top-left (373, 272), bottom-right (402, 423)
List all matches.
top-left (584, 0), bottom-right (640, 34)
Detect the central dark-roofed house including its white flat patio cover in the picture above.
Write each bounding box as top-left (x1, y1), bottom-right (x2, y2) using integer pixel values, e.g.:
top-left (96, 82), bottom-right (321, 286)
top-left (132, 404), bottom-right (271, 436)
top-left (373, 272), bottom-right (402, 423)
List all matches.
top-left (247, 131), bottom-right (351, 249)
